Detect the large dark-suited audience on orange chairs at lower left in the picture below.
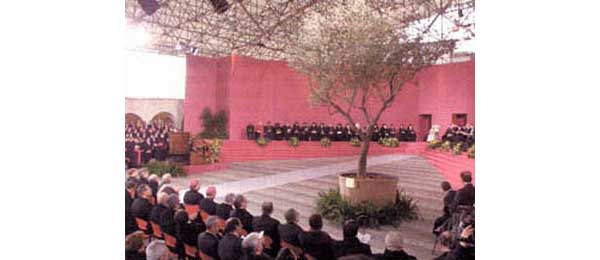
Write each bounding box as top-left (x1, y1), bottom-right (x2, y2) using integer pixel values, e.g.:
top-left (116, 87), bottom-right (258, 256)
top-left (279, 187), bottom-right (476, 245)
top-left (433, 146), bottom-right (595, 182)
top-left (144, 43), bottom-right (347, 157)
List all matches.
top-left (126, 171), bottom-right (448, 260)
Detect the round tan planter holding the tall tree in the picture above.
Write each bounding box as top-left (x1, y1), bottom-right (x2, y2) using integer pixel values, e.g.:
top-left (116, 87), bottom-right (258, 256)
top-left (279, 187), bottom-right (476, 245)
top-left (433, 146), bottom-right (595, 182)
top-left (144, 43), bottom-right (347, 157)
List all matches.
top-left (338, 173), bottom-right (398, 206)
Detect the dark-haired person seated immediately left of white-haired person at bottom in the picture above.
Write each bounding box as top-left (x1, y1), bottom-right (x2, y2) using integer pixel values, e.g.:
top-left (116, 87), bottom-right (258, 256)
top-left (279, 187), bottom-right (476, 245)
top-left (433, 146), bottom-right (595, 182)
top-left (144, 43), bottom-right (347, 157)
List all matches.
top-left (218, 218), bottom-right (242, 260)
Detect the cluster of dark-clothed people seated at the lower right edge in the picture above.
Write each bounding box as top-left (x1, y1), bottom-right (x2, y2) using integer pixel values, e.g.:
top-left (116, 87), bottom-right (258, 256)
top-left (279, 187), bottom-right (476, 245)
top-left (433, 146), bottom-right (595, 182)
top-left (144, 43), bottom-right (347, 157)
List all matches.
top-left (432, 171), bottom-right (475, 259)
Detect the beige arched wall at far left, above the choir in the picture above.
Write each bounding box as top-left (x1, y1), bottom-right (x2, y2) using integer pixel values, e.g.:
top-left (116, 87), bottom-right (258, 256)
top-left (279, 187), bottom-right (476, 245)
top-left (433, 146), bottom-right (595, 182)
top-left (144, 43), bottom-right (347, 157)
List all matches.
top-left (125, 98), bottom-right (183, 130)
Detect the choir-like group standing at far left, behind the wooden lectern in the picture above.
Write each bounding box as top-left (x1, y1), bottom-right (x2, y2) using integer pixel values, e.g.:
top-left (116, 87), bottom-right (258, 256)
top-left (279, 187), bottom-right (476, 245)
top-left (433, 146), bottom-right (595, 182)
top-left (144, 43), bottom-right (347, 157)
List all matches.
top-left (125, 121), bottom-right (175, 168)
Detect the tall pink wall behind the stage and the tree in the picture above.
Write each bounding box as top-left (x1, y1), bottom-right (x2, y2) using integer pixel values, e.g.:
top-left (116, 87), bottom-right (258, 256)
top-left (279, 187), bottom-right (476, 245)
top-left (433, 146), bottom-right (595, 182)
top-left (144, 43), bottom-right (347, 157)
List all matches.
top-left (184, 56), bottom-right (474, 140)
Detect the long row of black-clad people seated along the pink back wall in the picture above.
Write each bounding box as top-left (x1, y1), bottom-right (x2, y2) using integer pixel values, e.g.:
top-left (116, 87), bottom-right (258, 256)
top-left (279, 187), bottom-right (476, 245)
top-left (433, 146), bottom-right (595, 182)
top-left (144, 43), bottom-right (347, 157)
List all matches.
top-left (246, 121), bottom-right (417, 142)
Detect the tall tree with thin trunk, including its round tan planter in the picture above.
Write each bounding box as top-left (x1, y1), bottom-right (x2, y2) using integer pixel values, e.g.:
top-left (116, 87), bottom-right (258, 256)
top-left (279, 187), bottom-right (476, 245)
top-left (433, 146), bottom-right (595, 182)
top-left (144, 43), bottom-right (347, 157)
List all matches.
top-left (286, 0), bottom-right (455, 204)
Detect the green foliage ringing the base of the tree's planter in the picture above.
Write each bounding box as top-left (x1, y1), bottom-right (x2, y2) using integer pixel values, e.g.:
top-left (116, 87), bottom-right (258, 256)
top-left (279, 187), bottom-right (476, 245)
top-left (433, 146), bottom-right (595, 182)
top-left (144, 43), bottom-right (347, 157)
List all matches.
top-left (317, 189), bottom-right (419, 227)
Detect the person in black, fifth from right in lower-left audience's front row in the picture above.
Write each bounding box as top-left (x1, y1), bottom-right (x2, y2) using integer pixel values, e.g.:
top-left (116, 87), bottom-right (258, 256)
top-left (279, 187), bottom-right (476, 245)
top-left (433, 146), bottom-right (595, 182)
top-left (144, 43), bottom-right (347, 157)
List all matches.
top-left (252, 202), bottom-right (281, 257)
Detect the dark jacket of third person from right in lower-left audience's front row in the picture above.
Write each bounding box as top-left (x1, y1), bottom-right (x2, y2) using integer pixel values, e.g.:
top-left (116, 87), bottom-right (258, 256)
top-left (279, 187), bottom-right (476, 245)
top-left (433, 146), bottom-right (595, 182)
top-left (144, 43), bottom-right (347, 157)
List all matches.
top-left (298, 231), bottom-right (335, 260)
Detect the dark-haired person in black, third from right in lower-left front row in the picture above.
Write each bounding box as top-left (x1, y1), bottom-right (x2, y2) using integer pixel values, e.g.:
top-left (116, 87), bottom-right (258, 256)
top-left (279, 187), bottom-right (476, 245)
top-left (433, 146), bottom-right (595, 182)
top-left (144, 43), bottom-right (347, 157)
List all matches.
top-left (298, 214), bottom-right (335, 260)
